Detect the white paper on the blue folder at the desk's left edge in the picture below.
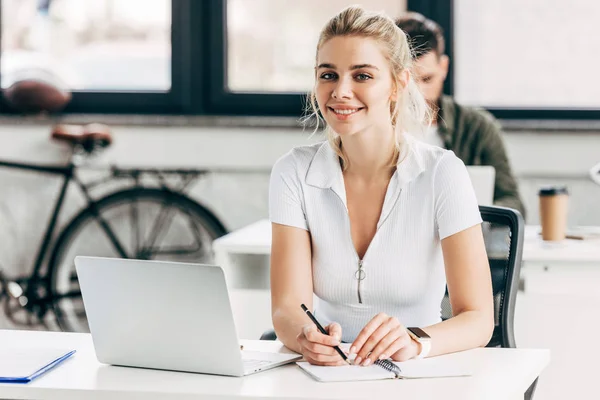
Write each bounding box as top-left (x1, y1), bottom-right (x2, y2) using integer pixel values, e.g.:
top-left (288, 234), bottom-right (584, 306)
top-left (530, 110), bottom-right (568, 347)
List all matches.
top-left (0, 348), bottom-right (70, 378)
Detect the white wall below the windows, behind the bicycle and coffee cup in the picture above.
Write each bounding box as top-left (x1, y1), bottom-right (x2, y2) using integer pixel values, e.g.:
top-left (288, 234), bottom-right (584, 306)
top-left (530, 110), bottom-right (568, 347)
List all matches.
top-left (0, 123), bottom-right (600, 280)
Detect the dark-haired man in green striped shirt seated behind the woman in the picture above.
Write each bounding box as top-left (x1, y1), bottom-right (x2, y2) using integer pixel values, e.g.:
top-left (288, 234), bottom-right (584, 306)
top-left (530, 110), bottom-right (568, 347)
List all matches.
top-left (396, 13), bottom-right (525, 217)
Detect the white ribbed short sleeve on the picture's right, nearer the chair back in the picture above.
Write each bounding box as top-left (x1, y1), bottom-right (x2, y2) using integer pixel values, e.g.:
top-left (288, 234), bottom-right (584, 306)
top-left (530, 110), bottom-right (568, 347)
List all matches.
top-left (433, 151), bottom-right (482, 239)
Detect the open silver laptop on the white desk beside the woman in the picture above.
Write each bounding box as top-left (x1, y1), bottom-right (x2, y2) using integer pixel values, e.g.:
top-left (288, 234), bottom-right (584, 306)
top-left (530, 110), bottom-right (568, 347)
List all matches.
top-left (75, 256), bottom-right (301, 376)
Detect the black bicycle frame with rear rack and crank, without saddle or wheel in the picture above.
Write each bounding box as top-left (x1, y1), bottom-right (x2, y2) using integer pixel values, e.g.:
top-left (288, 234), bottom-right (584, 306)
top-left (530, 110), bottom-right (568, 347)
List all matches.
top-left (0, 144), bottom-right (229, 328)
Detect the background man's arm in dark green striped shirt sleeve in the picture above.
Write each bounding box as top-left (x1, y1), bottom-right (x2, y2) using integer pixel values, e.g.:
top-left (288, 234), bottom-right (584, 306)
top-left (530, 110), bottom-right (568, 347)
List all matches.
top-left (480, 116), bottom-right (525, 219)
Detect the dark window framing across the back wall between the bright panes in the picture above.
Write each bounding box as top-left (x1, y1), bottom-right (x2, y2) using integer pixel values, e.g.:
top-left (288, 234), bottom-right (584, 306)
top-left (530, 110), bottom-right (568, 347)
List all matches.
top-left (0, 0), bottom-right (600, 120)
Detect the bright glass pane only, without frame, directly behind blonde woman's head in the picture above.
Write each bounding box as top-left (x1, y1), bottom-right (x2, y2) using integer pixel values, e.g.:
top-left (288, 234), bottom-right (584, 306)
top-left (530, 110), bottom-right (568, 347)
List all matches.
top-left (226, 0), bottom-right (406, 93)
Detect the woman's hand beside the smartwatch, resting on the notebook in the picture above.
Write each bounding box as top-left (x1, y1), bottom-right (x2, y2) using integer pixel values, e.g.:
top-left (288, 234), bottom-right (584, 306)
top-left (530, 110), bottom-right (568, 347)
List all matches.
top-left (350, 313), bottom-right (420, 366)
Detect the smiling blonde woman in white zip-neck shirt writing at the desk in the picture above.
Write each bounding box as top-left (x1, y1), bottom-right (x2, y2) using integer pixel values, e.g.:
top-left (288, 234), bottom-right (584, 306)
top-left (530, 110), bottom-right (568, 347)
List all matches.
top-left (269, 6), bottom-right (494, 365)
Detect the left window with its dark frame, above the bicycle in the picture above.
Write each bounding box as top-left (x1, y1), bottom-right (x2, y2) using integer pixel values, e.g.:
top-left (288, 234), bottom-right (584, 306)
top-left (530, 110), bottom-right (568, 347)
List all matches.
top-left (0, 0), bottom-right (185, 114)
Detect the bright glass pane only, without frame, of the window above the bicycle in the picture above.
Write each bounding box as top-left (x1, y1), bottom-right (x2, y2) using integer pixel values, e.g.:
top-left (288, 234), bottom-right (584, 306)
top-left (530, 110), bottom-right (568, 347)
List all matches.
top-left (0, 0), bottom-right (171, 92)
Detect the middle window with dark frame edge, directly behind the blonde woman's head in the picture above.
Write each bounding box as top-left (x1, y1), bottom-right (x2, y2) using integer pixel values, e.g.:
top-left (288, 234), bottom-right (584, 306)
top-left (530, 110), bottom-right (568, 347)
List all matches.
top-left (204, 0), bottom-right (406, 117)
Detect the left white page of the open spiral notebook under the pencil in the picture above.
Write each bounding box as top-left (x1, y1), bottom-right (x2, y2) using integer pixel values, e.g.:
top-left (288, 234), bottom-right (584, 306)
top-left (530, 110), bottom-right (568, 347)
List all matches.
top-left (296, 361), bottom-right (396, 382)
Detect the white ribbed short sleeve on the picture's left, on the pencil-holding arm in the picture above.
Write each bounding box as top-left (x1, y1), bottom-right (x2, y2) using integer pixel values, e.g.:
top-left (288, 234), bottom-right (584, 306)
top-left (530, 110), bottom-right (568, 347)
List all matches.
top-left (269, 153), bottom-right (308, 230)
